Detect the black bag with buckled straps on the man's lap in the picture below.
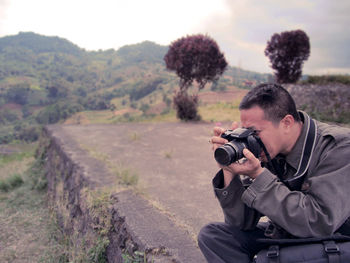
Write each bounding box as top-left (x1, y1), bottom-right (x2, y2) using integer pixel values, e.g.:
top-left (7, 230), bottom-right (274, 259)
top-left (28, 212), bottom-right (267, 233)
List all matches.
top-left (255, 235), bottom-right (350, 263)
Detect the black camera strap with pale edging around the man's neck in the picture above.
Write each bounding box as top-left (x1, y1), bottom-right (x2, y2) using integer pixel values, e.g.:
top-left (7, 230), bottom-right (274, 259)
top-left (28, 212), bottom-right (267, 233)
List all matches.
top-left (256, 114), bottom-right (317, 190)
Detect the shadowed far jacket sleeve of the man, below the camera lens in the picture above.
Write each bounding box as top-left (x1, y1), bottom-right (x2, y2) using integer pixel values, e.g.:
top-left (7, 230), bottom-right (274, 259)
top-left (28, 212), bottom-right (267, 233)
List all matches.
top-left (213, 170), bottom-right (261, 230)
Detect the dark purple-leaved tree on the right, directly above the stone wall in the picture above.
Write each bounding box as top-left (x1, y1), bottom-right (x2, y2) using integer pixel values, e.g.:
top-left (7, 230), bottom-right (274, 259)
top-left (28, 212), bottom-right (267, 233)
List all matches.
top-left (265, 30), bottom-right (310, 83)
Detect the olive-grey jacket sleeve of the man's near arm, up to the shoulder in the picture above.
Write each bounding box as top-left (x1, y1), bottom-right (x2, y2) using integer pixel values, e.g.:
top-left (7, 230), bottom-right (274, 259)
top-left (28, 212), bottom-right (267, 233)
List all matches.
top-left (242, 139), bottom-right (350, 237)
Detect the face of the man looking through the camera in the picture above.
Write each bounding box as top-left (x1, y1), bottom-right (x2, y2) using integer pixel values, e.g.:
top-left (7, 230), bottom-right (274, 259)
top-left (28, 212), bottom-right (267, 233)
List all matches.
top-left (241, 106), bottom-right (284, 162)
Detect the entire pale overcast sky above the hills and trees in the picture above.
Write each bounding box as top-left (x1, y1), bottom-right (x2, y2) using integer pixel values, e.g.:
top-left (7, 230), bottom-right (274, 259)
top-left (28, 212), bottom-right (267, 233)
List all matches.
top-left (0, 0), bottom-right (350, 74)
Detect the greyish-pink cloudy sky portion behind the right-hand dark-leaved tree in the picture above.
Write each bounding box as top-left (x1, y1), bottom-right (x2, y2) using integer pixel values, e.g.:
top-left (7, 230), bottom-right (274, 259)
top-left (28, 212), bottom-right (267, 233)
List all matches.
top-left (196, 0), bottom-right (350, 74)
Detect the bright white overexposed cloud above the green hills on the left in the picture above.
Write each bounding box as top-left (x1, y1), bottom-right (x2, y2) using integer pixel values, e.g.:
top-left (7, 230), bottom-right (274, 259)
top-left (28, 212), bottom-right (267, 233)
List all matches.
top-left (0, 0), bottom-right (227, 50)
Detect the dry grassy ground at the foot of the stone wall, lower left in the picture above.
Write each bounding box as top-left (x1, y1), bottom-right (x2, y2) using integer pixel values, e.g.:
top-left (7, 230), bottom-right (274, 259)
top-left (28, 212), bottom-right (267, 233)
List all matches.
top-left (0, 144), bottom-right (66, 263)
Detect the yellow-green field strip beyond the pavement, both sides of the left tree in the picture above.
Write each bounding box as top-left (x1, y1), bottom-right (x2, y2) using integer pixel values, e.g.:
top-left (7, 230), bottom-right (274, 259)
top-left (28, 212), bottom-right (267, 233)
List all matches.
top-left (64, 86), bottom-right (247, 124)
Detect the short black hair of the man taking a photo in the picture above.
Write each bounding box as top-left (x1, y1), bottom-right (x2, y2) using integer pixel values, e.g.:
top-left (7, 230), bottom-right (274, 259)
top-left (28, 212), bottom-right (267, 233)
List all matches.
top-left (239, 83), bottom-right (300, 123)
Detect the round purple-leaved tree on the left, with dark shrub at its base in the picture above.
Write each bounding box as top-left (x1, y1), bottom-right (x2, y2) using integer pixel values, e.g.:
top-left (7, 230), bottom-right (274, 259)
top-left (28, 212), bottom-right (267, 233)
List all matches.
top-left (164, 34), bottom-right (227, 120)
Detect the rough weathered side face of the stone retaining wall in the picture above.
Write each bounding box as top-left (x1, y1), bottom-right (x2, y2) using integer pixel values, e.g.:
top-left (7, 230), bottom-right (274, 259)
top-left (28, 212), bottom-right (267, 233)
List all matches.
top-left (38, 128), bottom-right (169, 262)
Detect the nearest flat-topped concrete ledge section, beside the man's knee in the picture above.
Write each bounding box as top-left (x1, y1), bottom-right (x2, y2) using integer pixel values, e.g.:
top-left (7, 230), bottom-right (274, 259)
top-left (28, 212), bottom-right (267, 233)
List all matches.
top-left (113, 191), bottom-right (204, 263)
